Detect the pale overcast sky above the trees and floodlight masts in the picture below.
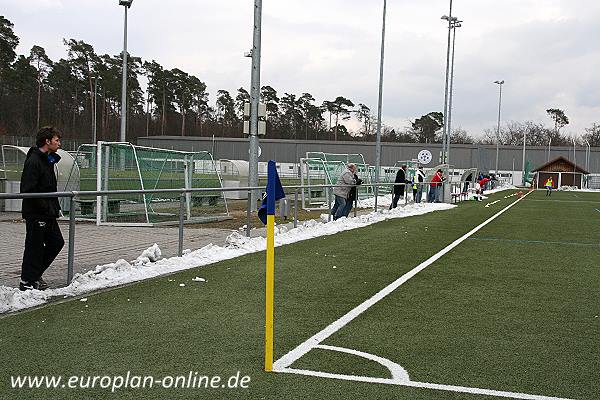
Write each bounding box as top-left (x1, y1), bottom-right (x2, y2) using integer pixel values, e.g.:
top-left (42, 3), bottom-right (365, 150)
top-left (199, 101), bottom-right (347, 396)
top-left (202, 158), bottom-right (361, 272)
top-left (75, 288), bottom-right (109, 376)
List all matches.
top-left (0, 0), bottom-right (600, 137)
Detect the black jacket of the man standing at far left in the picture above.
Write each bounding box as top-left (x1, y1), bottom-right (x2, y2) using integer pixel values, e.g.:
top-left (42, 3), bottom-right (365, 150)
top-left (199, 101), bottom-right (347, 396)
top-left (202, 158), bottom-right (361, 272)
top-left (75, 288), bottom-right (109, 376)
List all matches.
top-left (21, 147), bottom-right (60, 220)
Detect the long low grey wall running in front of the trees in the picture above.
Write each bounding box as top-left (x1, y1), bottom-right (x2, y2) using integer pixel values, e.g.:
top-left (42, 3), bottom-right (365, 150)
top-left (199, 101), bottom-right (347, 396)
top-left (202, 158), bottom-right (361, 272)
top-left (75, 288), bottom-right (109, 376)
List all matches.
top-left (138, 136), bottom-right (600, 173)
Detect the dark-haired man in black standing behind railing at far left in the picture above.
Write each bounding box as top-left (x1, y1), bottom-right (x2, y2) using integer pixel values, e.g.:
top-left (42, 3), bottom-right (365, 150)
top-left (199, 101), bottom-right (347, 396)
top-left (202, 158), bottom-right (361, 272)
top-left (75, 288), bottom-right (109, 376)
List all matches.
top-left (19, 126), bottom-right (65, 290)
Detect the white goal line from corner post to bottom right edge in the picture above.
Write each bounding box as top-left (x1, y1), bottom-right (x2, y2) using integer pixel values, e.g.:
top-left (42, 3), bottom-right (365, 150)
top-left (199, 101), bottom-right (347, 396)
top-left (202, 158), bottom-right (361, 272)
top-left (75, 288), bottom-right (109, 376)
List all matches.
top-left (277, 368), bottom-right (572, 400)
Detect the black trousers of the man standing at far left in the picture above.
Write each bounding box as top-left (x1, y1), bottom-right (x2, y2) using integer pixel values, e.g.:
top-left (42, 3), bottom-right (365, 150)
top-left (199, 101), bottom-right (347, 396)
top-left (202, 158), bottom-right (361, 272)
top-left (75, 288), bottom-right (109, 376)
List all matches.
top-left (21, 219), bottom-right (65, 282)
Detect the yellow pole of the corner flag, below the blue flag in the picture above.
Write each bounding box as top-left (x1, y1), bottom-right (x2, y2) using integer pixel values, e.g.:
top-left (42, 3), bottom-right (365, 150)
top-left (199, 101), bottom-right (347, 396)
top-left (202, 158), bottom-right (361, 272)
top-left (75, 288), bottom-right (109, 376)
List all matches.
top-left (265, 215), bottom-right (275, 372)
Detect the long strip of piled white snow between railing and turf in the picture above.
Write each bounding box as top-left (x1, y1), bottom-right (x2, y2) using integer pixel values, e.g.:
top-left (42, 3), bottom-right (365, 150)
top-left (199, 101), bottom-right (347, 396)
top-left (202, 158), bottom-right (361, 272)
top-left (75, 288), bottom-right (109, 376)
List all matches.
top-left (0, 203), bottom-right (456, 314)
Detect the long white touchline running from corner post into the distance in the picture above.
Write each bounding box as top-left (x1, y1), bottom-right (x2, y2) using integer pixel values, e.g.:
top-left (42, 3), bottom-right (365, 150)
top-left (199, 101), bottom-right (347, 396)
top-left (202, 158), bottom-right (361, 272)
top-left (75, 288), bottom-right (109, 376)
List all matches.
top-left (273, 192), bottom-right (531, 372)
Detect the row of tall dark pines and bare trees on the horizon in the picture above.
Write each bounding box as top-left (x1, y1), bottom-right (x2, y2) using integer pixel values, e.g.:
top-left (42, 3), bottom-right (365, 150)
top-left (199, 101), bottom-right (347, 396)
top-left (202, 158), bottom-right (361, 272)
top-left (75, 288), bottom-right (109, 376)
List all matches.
top-left (0, 16), bottom-right (600, 146)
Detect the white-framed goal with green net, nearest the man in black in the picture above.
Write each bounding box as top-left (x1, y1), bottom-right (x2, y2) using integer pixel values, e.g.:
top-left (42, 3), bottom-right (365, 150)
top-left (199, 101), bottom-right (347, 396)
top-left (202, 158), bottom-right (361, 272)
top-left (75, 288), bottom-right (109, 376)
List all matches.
top-left (63, 142), bottom-right (229, 226)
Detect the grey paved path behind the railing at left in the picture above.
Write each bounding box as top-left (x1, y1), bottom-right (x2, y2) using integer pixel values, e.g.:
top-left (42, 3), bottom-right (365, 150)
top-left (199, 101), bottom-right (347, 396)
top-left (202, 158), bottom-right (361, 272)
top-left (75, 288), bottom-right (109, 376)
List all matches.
top-left (0, 213), bottom-right (232, 287)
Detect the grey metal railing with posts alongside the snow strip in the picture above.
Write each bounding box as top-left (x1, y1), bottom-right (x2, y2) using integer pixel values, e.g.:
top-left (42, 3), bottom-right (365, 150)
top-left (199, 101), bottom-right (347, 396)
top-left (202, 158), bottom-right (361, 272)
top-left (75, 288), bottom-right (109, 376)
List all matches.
top-left (0, 182), bottom-right (445, 285)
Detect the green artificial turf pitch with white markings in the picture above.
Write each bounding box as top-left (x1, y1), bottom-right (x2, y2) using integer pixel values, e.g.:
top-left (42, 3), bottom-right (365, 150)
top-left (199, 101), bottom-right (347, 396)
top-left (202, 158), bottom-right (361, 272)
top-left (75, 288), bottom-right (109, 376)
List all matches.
top-left (0, 191), bottom-right (600, 400)
